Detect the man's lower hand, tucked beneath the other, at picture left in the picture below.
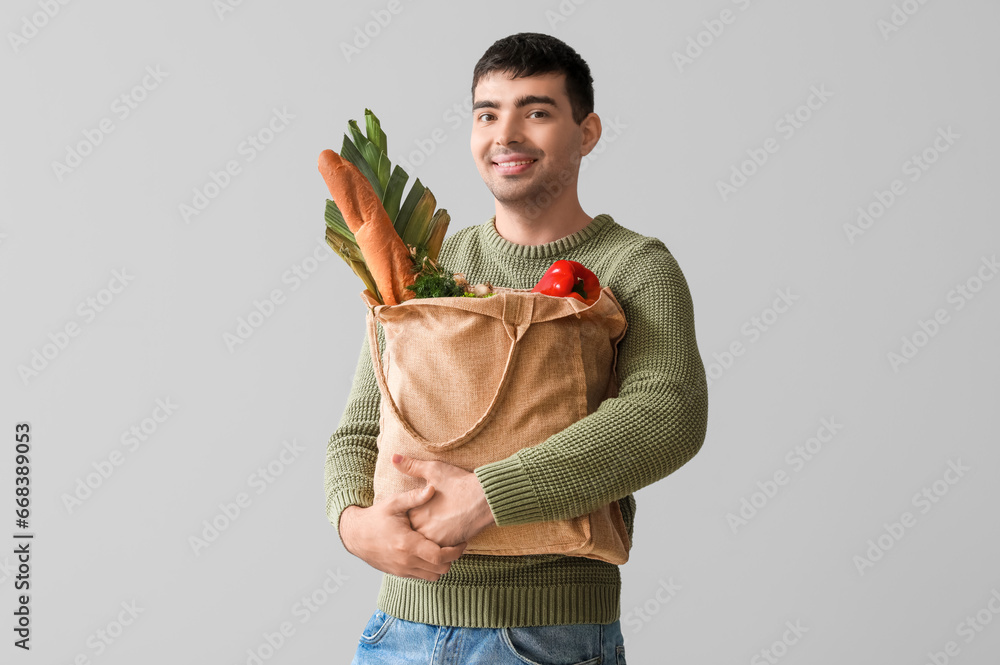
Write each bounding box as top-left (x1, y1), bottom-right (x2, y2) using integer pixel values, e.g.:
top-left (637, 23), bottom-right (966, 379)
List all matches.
top-left (340, 485), bottom-right (467, 582)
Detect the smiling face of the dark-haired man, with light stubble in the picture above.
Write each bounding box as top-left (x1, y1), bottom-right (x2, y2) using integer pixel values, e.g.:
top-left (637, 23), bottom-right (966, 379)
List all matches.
top-left (471, 72), bottom-right (596, 213)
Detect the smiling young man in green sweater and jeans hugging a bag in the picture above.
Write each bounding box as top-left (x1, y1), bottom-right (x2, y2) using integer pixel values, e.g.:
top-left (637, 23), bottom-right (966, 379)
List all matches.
top-left (325, 33), bottom-right (708, 665)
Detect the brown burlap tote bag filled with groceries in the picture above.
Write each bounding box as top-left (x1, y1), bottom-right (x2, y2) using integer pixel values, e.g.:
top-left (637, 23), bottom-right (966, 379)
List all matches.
top-left (361, 287), bottom-right (631, 564)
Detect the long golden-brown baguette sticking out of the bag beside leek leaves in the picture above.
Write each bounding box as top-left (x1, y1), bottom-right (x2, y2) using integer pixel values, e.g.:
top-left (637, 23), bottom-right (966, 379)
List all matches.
top-left (319, 150), bottom-right (417, 305)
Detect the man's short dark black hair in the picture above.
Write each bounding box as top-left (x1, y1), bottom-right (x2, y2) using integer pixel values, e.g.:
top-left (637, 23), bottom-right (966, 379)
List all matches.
top-left (472, 32), bottom-right (594, 125)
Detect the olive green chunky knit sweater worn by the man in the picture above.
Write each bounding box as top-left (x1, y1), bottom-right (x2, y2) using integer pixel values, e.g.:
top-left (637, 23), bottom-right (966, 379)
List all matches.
top-left (325, 214), bottom-right (708, 628)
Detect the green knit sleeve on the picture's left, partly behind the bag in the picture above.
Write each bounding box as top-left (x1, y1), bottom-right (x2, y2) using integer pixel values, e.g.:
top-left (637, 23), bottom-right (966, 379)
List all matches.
top-left (323, 326), bottom-right (385, 543)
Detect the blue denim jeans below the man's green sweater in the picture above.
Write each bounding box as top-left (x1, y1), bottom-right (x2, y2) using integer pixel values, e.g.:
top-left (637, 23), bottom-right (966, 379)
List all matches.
top-left (351, 609), bottom-right (626, 665)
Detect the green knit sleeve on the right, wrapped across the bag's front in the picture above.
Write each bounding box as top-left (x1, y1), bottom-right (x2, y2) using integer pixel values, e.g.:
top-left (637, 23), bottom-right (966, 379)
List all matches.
top-left (475, 237), bottom-right (708, 526)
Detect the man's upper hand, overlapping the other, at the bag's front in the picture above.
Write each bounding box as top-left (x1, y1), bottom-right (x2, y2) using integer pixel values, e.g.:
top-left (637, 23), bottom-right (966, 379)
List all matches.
top-left (392, 453), bottom-right (496, 546)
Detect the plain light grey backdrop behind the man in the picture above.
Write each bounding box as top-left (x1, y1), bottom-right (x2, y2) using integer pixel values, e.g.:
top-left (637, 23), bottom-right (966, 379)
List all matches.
top-left (0, 0), bottom-right (1000, 665)
